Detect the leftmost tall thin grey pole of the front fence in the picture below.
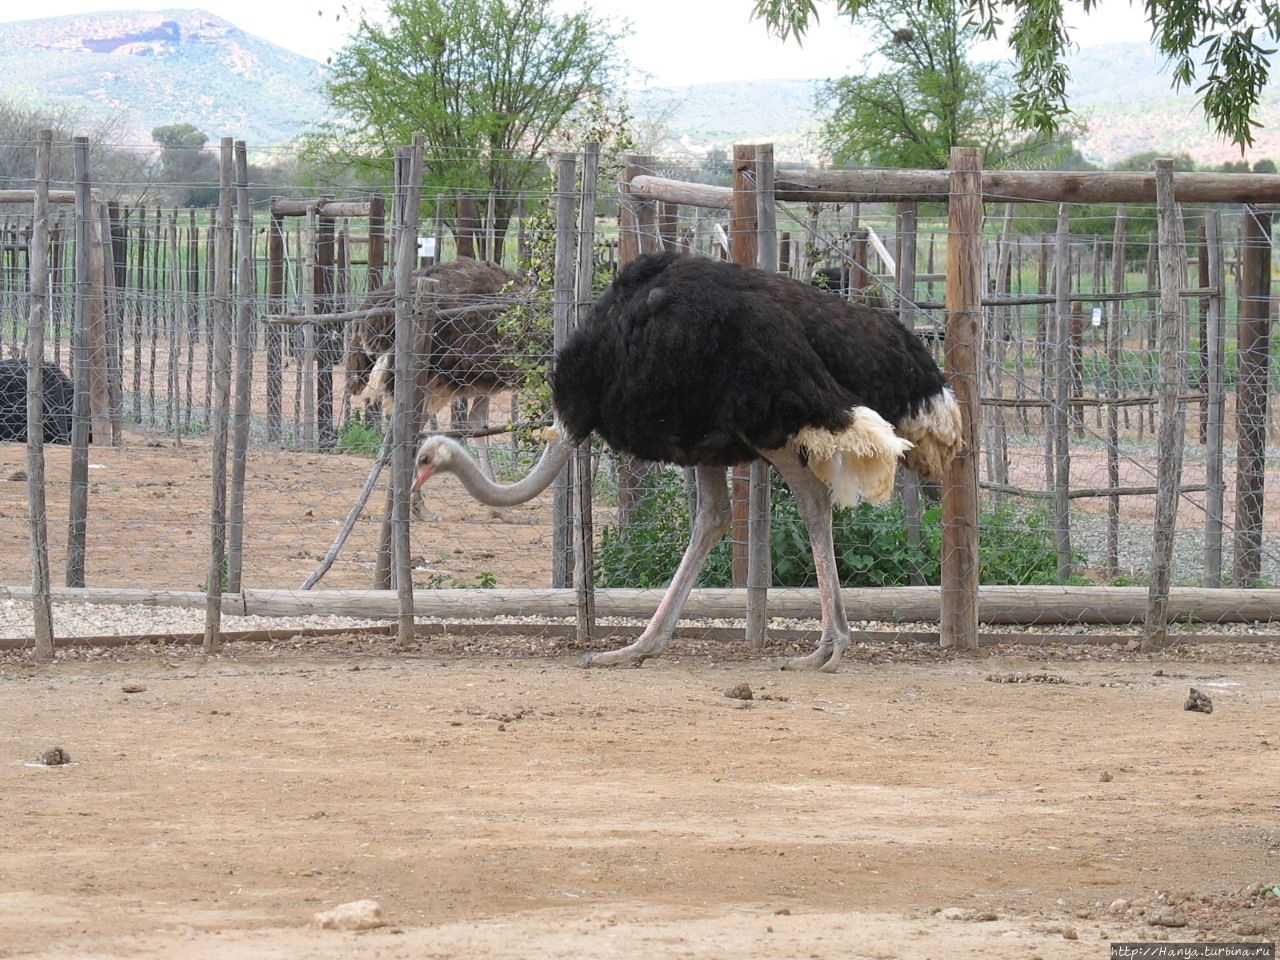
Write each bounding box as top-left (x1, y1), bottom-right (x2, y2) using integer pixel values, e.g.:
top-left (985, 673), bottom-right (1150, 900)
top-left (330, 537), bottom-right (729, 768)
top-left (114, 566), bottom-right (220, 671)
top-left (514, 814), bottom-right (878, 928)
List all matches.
top-left (27, 129), bottom-right (54, 660)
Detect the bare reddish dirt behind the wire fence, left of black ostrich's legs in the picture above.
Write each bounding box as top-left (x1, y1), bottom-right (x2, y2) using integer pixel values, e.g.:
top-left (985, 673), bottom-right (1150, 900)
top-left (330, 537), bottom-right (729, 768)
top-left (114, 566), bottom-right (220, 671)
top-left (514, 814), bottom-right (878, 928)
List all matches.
top-left (0, 431), bottom-right (552, 590)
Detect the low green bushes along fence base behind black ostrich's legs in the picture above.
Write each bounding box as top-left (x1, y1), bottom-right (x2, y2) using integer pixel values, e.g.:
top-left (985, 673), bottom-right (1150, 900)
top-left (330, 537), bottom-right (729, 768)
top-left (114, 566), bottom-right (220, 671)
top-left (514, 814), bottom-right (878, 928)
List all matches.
top-left (595, 470), bottom-right (1059, 588)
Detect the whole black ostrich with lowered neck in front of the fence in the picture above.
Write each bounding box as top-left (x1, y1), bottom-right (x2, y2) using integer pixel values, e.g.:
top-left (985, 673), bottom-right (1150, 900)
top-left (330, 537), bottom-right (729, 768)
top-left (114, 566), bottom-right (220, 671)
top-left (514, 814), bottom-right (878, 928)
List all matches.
top-left (413, 253), bottom-right (961, 671)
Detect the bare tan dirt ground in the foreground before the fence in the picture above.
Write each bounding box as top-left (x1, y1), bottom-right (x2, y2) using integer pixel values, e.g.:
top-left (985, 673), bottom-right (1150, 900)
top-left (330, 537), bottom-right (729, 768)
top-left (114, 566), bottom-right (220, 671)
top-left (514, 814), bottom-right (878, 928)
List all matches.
top-left (0, 637), bottom-right (1280, 960)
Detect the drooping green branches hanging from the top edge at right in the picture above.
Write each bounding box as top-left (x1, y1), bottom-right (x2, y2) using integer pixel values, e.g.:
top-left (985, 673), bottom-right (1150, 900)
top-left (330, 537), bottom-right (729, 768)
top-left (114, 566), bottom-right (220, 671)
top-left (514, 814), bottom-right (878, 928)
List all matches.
top-left (753, 0), bottom-right (1280, 148)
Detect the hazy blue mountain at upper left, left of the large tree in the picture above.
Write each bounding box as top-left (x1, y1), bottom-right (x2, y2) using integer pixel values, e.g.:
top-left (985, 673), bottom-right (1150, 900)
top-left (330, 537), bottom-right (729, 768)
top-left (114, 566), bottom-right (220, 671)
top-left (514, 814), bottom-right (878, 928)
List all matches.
top-left (0, 9), bottom-right (328, 146)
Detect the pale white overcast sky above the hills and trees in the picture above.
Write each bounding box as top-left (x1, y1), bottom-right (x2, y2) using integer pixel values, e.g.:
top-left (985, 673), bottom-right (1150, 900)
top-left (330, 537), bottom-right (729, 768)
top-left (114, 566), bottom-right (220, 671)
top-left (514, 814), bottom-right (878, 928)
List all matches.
top-left (0, 0), bottom-right (1151, 86)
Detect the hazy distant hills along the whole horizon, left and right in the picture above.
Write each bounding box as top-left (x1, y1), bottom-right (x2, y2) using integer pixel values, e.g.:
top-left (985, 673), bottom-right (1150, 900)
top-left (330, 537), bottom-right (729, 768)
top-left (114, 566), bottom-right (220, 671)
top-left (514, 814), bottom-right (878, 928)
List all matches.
top-left (0, 9), bottom-right (1280, 164)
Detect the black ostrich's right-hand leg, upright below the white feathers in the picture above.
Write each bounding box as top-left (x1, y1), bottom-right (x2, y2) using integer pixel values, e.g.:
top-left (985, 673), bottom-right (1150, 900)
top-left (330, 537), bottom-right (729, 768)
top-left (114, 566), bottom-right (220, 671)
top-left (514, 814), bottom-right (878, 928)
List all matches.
top-left (765, 447), bottom-right (849, 673)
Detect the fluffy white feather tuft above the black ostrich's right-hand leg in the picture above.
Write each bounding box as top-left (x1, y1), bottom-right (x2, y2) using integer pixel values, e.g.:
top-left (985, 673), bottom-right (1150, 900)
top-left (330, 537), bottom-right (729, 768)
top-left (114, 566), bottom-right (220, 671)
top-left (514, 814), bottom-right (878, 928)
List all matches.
top-left (791, 407), bottom-right (911, 507)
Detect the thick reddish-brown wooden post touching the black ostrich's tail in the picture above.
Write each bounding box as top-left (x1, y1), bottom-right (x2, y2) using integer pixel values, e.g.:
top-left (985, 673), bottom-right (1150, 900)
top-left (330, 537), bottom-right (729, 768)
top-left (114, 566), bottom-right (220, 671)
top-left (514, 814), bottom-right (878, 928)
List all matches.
top-left (940, 147), bottom-right (983, 650)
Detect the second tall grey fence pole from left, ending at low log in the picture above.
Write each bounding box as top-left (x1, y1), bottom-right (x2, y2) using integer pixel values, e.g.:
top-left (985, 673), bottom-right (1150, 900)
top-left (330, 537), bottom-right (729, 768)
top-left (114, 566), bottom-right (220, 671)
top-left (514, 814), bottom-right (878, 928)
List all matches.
top-left (67, 137), bottom-right (93, 586)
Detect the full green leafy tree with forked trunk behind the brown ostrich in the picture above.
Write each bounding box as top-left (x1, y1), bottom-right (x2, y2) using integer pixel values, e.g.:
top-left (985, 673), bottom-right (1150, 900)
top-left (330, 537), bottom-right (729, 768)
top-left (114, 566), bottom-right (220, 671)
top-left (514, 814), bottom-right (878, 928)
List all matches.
top-left (319, 0), bottom-right (621, 260)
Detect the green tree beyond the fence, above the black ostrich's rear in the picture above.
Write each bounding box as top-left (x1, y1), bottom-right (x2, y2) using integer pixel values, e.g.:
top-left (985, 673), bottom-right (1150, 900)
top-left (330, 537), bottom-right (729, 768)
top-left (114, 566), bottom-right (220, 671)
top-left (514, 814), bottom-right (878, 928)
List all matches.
top-left (818, 0), bottom-right (1034, 169)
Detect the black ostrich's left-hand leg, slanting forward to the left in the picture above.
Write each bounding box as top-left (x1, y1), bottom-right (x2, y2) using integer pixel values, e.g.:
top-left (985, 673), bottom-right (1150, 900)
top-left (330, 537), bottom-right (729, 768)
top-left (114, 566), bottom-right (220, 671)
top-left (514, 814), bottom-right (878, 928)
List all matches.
top-left (580, 466), bottom-right (730, 667)
